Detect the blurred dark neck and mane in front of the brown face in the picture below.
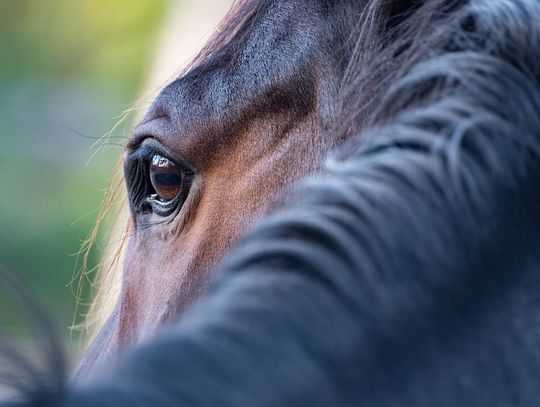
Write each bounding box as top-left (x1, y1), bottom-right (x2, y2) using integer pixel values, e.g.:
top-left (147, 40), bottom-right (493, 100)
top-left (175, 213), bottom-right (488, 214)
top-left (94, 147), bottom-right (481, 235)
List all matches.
top-left (4, 0), bottom-right (540, 406)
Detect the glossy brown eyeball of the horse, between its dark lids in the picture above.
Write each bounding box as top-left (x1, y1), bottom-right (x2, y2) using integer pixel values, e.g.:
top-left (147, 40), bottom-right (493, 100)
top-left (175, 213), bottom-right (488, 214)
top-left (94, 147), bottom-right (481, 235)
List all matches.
top-left (150, 154), bottom-right (183, 201)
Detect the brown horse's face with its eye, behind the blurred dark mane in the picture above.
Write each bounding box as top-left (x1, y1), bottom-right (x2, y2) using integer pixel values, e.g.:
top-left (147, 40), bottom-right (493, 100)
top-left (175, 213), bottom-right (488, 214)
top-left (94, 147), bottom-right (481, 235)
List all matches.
top-left (77, 0), bottom-right (448, 377)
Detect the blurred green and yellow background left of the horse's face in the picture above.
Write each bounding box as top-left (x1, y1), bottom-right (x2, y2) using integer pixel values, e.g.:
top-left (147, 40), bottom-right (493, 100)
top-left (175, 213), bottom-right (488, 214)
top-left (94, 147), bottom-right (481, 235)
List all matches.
top-left (0, 0), bottom-right (166, 344)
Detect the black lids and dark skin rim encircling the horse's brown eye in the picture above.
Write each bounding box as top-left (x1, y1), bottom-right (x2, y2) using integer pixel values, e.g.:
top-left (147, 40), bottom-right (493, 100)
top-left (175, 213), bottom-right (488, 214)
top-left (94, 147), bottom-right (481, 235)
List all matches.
top-left (124, 146), bottom-right (194, 217)
